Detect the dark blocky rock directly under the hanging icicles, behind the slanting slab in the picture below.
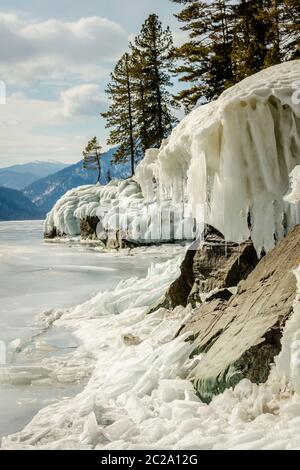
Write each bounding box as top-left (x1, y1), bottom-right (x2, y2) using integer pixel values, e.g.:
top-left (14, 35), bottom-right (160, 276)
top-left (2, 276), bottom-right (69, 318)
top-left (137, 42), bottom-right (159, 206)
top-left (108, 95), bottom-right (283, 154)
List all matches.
top-left (164, 225), bottom-right (258, 308)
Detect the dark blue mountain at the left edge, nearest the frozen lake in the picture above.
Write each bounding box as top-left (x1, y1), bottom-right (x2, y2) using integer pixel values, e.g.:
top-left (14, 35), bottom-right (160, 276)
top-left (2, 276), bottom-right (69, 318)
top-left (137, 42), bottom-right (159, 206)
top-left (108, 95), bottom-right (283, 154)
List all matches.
top-left (0, 187), bottom-right (44, 221)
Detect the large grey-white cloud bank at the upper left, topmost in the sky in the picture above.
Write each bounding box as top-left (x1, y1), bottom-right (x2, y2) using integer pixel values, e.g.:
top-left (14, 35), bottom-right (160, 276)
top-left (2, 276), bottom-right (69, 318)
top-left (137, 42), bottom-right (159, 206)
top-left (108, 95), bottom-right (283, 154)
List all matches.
top-left (0, 12), bottom-right (127, 85)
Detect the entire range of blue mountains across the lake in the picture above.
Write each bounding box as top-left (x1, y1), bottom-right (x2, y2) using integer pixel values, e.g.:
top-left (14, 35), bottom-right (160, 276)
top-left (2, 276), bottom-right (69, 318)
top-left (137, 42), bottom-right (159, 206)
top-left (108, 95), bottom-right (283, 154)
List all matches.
top-left (0, 149), bottom-right (131, 221)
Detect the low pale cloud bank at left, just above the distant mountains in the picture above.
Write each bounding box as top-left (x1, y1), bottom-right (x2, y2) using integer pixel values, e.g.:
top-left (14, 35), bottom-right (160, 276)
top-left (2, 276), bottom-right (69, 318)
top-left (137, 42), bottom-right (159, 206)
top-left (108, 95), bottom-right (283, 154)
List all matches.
top-left (0, 94), bottom-right (95, 167)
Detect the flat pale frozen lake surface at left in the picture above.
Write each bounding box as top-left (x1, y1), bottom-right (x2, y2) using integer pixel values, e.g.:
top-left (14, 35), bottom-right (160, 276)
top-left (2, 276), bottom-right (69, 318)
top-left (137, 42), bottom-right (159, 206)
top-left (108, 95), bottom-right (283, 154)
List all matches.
top-left (0, 221), bottom-right (172, 437)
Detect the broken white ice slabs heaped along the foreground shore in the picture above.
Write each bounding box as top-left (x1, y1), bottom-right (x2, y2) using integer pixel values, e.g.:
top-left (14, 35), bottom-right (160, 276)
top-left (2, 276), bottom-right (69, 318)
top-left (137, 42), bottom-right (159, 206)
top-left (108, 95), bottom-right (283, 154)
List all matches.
top-left (2, 255), bottom-right (300, 449)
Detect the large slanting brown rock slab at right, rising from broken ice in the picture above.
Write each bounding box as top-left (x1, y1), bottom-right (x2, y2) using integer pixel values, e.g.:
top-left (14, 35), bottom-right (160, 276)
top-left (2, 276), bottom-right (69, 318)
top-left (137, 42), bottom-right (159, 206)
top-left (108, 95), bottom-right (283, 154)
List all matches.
top-left (183, 225), bottom-right (300, 402)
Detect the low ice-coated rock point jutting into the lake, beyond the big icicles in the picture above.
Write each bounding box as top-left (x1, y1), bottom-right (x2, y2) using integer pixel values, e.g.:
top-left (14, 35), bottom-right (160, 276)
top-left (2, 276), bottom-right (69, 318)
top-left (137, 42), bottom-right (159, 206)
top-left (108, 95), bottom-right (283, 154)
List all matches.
top-left (44, 179), bottom-right (196, 248)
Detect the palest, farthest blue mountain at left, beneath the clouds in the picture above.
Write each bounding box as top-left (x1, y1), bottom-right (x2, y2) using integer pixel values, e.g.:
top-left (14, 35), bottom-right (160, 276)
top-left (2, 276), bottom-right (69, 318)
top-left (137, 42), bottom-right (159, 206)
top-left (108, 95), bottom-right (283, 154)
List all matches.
top-left (0, 161), bottom-right (68, 190)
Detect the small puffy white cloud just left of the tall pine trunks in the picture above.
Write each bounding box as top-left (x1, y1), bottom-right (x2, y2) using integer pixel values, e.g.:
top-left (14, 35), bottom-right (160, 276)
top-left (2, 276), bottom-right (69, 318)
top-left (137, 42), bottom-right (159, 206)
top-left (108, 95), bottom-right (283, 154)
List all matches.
top-left (58, 84), bottom-right (106, 119)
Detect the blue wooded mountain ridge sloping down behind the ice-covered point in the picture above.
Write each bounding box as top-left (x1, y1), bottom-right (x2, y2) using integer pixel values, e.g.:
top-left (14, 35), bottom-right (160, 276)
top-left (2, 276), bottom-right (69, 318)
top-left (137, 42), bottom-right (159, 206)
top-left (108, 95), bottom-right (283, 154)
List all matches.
top-left (23, 149), bottom-right (131, 214)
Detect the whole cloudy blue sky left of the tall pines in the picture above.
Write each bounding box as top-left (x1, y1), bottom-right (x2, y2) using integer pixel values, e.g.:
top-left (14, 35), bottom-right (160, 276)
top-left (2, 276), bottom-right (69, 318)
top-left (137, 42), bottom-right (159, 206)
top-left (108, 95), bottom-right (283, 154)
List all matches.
top-left (0, 0), bottom-right (184, 167)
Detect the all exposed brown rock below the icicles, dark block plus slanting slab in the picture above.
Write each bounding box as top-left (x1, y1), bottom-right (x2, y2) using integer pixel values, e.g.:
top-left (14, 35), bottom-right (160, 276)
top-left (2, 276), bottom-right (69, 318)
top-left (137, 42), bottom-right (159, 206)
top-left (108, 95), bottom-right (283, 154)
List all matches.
top-left (172, 225), bottom-right (300, 402)
